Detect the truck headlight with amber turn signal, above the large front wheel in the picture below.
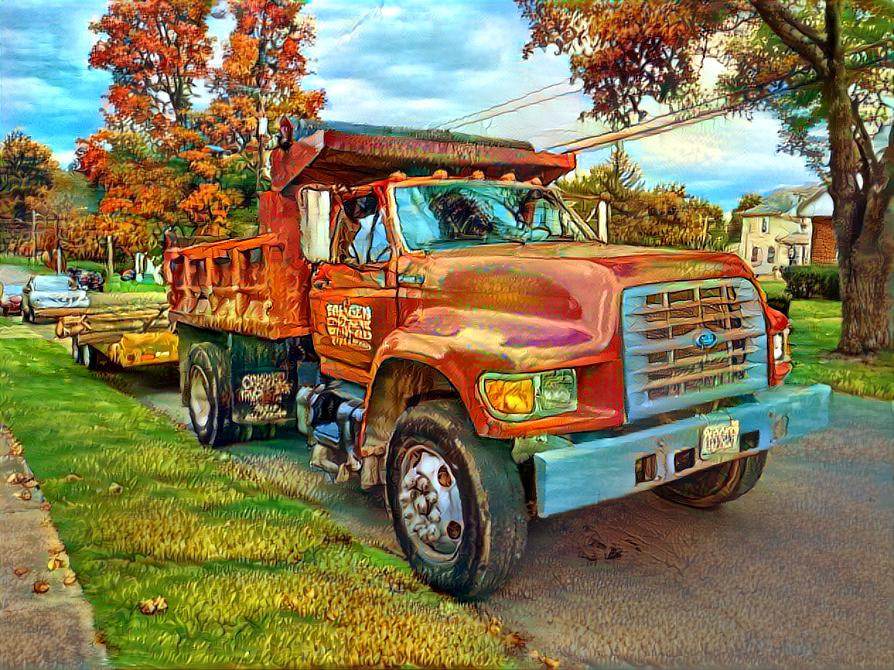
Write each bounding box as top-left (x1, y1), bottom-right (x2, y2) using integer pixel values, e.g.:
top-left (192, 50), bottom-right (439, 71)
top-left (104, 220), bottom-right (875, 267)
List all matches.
top-left (480, 370), bottom-right (577, 421)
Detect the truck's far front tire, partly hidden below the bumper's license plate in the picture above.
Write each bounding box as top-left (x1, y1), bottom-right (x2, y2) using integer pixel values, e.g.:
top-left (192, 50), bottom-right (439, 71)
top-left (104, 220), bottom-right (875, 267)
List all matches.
top-left (652, 451), bottom-right (767, 508)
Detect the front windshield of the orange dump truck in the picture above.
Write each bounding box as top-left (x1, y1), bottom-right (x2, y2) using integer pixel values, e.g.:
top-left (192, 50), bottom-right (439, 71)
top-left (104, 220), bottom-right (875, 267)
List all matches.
top-left (394, 181), bottom-right (596, 250)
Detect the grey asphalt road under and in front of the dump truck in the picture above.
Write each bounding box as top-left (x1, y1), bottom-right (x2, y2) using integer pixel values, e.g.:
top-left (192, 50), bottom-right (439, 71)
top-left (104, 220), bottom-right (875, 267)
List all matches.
top-left (1, 262), bottom-right (894, 668)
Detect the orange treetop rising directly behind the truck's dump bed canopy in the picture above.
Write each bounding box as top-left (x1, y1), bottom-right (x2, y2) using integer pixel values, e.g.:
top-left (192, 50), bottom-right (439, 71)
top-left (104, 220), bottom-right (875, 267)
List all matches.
top-left (202, 0), bottom-right (325, 190)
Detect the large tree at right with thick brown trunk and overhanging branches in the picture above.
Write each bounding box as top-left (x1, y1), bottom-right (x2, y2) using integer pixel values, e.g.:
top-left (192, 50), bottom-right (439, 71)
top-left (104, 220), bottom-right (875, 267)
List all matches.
top-left (516, 0), bottom-right (894, 354)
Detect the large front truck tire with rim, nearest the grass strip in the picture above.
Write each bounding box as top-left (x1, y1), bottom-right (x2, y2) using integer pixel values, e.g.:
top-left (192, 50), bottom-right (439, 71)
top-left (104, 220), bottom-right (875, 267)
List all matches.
top-left (385, 400), bottom-right (528, 599)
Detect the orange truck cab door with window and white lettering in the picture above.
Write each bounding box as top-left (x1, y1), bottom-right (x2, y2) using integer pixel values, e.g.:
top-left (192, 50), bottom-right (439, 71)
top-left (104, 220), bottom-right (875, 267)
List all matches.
top-left (310, 193), bottom-right (397, 383)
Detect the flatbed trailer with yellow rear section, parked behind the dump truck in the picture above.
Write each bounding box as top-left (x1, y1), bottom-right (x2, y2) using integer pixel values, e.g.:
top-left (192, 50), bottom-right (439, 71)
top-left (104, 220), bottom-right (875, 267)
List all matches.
top-left (56, 302), bottom-right (178, 369)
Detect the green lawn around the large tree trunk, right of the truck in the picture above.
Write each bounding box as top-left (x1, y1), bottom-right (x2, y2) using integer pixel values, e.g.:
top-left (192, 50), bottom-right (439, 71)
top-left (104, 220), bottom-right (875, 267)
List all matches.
top-left (788, 300), bottom-right (894, 400)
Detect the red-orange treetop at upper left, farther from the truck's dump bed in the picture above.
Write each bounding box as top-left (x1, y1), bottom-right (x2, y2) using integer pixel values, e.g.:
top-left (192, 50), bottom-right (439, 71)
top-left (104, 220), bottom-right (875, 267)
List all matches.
top-left (90, 0), bottom-right (212, 136)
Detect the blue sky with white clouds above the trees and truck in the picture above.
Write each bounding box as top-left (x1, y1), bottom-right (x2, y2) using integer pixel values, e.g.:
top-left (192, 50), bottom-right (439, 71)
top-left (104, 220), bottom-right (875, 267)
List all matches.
top-left (0, 0), bottom-right (814, 209)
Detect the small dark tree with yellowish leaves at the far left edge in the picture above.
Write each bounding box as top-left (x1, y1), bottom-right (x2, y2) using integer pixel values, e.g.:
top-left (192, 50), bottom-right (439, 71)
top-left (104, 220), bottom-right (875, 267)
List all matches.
top-left (0, 130), bottom-right (59, 219)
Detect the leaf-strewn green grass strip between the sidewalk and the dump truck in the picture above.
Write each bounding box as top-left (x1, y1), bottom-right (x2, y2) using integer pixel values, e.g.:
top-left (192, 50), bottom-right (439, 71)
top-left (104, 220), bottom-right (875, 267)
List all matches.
top-left (0, 339), bottom-right (512, 667)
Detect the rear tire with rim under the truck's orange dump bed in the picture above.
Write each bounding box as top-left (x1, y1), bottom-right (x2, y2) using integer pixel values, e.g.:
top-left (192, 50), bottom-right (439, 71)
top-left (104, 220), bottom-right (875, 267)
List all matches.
top-left (186, 342), bottom-right (235, 447)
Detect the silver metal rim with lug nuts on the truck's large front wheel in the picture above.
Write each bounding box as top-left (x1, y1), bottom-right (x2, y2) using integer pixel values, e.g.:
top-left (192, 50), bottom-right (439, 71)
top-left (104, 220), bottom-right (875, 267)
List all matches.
top-left (398, 444), bottom-right (464, 562)
